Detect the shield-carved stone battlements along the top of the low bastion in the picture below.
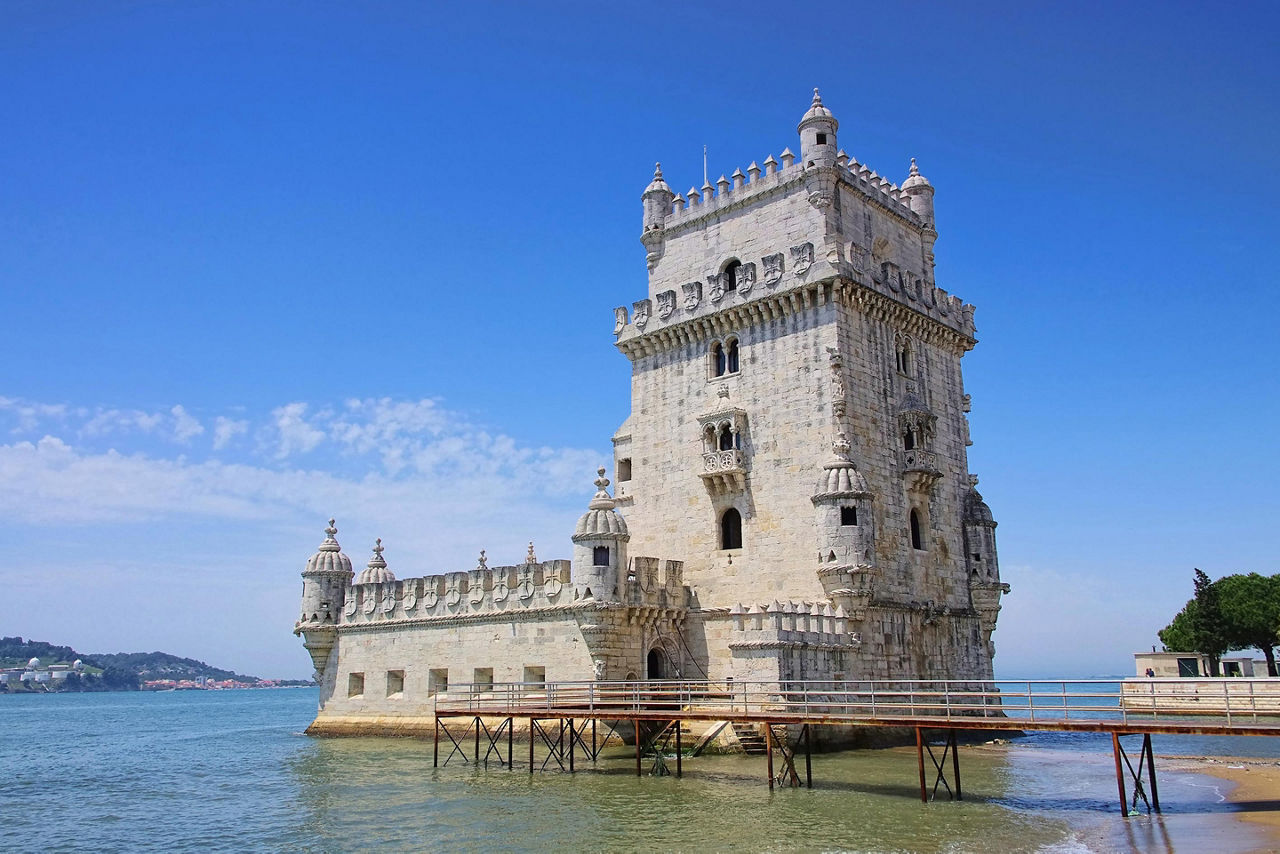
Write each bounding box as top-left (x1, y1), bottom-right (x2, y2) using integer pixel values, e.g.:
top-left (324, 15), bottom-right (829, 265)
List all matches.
top-left (340, 557), bottom-right (689, 625)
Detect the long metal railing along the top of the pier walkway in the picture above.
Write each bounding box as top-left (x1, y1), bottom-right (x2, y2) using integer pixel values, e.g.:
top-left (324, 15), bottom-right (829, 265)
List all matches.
top-left (434, 679), bottom-right (1280, 730)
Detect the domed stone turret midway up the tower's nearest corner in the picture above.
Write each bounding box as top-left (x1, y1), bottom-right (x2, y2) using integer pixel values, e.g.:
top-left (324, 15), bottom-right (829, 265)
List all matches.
top-left (813, 433), bottom-right (876, 621)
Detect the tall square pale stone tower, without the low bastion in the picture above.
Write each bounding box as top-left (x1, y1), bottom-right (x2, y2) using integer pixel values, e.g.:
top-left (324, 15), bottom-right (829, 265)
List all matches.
top-left (611, 90), bottom-right (1009, 679)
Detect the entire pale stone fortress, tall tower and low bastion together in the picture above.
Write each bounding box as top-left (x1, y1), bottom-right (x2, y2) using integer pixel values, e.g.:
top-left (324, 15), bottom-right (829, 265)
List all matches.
top-left (294, 90), bottom-right (1009, 734)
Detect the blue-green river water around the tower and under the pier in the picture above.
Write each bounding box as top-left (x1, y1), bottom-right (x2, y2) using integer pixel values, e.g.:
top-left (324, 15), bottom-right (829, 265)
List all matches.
top-left (0, 690), bottom-right (1275, 853)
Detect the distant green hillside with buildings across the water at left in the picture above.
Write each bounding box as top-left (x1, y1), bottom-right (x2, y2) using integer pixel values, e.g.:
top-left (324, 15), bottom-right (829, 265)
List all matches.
top-left (0, 638), bottom-right (306, 690)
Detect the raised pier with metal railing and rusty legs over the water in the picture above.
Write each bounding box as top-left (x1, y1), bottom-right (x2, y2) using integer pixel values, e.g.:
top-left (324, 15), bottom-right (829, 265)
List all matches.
top-left (434, 679), bottom-right (1280, 816)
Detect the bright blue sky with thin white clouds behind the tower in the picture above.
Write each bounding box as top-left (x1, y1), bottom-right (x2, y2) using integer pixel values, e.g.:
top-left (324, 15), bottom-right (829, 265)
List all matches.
top-left (0, 0), bottom-right (1280, 676)
